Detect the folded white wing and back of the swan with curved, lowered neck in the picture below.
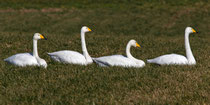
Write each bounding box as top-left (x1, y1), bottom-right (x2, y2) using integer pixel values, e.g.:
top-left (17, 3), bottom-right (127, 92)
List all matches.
top-left (93, 55), bottom-right (137, 67)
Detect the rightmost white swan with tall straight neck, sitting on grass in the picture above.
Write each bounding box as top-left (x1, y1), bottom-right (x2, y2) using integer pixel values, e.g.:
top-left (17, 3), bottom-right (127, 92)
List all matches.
top-left (147, 27), bottom-right (196, 65)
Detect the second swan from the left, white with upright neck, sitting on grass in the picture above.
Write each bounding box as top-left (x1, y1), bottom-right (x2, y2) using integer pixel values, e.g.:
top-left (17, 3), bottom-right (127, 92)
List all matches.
top-left (48, 26), bottom-right (93, 65)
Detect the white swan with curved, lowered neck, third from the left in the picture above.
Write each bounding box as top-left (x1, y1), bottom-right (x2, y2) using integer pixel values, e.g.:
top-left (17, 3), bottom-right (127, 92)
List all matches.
top-left (93, 40), bottom-right (145, 68)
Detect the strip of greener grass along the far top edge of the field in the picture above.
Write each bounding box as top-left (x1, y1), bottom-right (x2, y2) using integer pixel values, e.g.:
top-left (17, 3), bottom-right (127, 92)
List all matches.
top-left (0, 0), bottom-right (208, 9)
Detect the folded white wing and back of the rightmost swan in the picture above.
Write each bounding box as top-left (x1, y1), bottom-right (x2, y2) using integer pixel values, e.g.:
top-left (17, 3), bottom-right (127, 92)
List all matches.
top-left (147, 54), bottom-right (188, 65)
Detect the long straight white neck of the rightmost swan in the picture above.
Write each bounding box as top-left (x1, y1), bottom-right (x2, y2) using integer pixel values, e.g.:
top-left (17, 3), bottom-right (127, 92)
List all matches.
top-left (185, 32), bottom-right (196, 65)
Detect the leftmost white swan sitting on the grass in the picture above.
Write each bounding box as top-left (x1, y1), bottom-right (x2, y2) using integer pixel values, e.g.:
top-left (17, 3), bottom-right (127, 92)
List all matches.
top-left (4, 33), bottom-right (47, 68)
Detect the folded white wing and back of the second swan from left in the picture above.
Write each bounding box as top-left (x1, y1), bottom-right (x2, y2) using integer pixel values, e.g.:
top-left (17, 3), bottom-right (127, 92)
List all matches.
top-left (48, 50), bottom-right (86, 65)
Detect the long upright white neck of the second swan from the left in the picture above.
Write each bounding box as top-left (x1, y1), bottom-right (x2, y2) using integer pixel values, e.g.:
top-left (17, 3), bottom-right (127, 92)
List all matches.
top-left (81, 31), bottom-right (93, 63)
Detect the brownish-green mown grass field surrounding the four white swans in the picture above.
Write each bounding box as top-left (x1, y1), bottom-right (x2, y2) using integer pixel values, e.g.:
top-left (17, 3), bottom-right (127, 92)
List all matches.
top-left (0, 0), bottom-right (210, 105)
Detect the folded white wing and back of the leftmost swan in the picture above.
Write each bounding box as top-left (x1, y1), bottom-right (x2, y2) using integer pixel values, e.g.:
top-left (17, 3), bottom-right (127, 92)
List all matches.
top-left (4, 53), bottom-right (38, 66)
